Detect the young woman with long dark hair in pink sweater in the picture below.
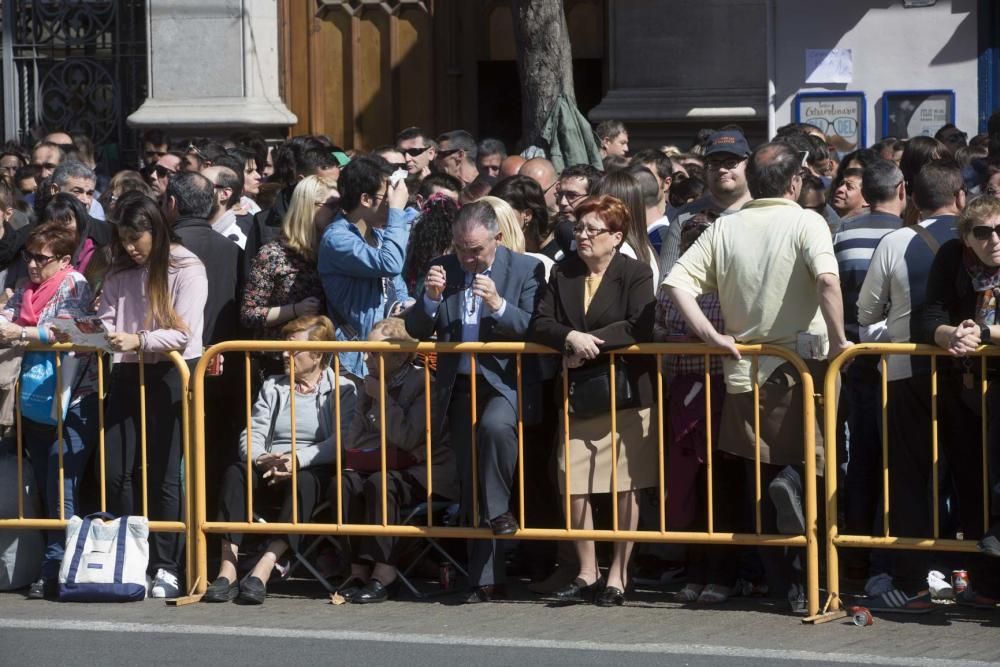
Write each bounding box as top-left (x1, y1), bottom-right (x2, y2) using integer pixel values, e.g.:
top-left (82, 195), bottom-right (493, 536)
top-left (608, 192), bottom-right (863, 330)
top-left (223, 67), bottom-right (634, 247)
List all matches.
top-left (98, 193), bottom-right (208, 597)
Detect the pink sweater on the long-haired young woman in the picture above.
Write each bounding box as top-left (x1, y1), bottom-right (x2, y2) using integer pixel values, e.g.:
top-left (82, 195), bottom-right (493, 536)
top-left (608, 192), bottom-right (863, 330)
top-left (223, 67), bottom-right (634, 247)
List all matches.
top-left (97, 245), bottom-right (208, 363)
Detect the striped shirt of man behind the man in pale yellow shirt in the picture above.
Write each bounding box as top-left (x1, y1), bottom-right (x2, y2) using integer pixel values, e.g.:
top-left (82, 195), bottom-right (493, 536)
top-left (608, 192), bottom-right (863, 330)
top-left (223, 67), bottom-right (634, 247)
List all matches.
top-left (833, 213), bottom-right (903, 343)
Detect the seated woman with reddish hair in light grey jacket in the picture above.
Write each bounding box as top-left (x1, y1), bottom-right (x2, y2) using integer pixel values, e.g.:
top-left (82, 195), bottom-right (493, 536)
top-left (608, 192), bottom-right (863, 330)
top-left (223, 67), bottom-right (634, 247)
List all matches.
top-left (202, 315), bottom-right (357, 604)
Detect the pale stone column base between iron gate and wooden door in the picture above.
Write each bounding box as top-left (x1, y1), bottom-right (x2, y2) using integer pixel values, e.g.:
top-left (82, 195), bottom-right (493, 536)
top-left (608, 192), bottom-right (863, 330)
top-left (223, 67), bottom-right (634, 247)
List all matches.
top-left (128, 0), bottom-right (297, 134)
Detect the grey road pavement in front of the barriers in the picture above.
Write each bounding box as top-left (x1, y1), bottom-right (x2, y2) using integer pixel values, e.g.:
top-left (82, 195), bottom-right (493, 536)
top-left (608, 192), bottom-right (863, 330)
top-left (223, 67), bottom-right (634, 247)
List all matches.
top-left (0, 583), bottom-right (1000, 665)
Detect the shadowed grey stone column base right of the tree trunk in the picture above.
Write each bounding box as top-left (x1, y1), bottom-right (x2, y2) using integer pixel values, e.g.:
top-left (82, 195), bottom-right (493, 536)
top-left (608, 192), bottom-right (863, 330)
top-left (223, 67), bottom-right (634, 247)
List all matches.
top-left (590, 0), bottom-right (768, 150)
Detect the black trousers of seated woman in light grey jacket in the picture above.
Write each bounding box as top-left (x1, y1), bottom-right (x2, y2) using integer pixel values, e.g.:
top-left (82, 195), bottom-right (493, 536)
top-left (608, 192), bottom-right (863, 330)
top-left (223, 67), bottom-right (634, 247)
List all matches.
top-left (219, 462), bottom-right (330, 549)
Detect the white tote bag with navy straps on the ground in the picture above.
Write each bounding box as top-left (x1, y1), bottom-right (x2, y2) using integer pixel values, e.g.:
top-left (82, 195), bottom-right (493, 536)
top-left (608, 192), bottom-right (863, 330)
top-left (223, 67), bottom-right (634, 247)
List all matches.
top-left (59, 514), bottom-right (149, 602)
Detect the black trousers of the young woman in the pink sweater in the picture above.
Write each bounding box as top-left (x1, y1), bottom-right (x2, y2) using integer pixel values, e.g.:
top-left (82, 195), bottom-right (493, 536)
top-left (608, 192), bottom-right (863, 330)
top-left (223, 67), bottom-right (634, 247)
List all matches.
top-left (104, 361), bottom-right (184, 574)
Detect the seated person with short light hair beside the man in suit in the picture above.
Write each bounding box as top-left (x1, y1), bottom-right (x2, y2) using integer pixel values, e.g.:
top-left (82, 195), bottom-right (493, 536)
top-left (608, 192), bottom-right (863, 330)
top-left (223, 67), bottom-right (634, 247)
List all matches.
top-left (336, 318), bottom-right (458, 604)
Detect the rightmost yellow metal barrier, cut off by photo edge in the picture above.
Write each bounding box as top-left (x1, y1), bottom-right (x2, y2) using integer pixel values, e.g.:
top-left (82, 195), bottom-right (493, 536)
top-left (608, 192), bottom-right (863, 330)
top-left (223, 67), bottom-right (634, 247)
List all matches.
top-left (824, 343), bottom-right (1000, 611)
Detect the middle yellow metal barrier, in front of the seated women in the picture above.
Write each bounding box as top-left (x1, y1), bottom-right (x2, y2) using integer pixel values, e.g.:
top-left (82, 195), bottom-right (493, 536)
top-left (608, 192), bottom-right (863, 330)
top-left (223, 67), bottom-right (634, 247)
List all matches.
top-left (188, 341), bottom-right (819, 614)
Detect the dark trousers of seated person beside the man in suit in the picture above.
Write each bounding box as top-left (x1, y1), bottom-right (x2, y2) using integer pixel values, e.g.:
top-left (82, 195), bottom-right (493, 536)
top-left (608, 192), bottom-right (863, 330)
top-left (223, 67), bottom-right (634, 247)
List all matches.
top-left (338, 470), bottom-right (427, 565)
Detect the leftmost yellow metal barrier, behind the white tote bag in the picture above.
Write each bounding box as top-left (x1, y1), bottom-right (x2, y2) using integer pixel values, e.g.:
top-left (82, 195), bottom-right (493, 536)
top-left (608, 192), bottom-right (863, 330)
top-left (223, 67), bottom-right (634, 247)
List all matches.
top-left (0, 343), bottom-right (194, 592)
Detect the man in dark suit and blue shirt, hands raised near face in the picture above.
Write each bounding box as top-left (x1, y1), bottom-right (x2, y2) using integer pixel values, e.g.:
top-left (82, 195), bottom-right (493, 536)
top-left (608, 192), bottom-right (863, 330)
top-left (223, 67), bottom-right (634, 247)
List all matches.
top-left (406, 202), bottom-right (545, 602)
